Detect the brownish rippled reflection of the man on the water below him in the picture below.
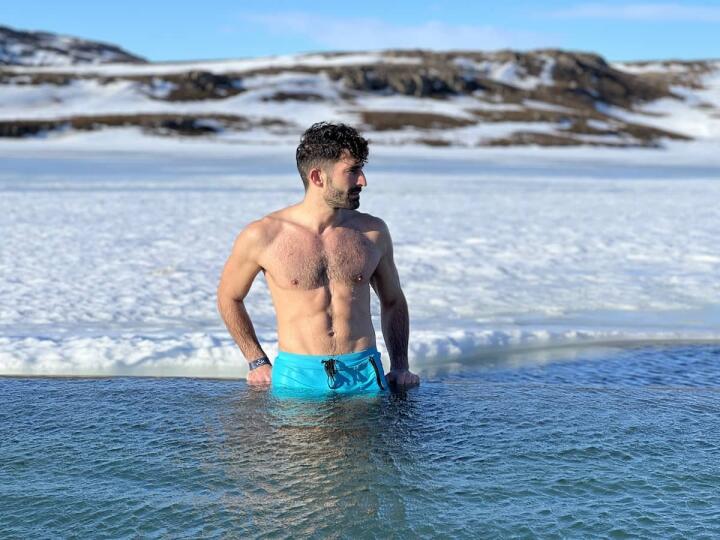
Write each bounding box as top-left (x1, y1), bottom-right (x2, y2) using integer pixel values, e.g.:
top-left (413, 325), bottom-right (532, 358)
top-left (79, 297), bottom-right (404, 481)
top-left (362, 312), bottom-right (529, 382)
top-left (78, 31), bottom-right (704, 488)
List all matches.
top-left (219, 390), bottom-right (412, 536)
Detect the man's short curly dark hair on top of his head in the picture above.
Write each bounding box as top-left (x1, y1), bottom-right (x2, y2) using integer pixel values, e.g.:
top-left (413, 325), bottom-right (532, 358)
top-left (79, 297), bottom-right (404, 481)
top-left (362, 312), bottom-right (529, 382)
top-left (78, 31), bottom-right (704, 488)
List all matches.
top-left (295, 122), bottom-right (368, 191)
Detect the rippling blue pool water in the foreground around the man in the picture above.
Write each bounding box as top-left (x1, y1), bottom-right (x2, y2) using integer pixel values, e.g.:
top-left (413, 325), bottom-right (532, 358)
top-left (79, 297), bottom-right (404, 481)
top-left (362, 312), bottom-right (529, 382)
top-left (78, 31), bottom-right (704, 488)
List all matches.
top-left (0, 344), bottom-right (720, 538)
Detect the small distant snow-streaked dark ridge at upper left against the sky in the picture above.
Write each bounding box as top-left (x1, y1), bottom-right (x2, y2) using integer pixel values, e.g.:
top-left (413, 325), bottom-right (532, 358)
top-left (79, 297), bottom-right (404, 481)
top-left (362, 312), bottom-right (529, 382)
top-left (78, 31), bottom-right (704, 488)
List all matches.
top-left (0, 26), bottom-right (147, 66)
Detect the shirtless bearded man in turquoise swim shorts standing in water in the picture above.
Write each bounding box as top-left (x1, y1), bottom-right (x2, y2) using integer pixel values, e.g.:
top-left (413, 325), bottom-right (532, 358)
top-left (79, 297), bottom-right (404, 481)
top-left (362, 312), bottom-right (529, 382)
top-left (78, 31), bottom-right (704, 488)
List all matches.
top-left (218, 122), bottom-right (420, 392)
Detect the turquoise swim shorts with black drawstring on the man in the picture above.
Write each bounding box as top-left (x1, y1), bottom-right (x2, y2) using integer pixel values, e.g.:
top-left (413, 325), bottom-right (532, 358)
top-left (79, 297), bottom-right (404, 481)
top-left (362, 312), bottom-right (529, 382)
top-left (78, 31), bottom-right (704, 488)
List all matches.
top-left (271, 347), bottom-right (388, 394)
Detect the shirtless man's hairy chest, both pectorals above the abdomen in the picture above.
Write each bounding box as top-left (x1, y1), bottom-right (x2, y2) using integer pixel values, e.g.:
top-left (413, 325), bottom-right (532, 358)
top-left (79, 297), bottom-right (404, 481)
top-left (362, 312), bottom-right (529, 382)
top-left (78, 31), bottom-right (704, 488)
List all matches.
top-left (262, 228), bottom-right (381, 289)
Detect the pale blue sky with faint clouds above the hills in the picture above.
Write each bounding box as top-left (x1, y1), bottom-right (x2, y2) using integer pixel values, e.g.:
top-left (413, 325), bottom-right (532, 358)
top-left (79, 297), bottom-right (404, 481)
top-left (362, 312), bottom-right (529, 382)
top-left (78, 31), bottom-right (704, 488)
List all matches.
top-left (0, 0), bottom-right (720, 61)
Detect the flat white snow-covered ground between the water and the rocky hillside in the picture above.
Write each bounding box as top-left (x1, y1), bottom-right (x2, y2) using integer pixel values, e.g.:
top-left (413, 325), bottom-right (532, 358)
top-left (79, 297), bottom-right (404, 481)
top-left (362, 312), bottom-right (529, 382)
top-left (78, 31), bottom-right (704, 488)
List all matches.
top-left (0, 129), bottom-right (720, 376)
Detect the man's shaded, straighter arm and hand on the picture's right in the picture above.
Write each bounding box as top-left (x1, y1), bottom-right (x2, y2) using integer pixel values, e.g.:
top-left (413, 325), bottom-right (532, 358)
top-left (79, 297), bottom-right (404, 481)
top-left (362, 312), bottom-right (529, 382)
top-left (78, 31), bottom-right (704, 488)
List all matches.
top-left (370, 220), bottom-right (420, 386)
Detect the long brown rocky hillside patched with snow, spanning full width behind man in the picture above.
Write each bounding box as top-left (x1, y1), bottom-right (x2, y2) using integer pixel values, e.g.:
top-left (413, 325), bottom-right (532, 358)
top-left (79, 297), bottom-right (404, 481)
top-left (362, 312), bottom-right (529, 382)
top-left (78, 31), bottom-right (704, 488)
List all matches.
top-left (0, 26), bottom-right (720, 147)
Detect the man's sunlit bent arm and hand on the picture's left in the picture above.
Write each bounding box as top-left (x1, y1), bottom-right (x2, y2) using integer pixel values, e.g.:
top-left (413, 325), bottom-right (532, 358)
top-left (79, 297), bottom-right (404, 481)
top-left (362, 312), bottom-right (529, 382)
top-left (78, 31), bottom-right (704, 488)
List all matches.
top-left (217, 221), bottom-right (271, 384)
